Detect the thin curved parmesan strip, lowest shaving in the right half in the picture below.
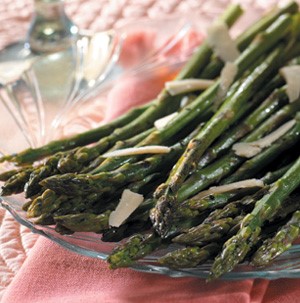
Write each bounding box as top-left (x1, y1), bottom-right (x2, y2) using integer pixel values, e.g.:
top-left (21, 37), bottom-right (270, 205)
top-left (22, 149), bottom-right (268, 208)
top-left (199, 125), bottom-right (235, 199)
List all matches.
top-left (193, 179), bottom-right (264, 200)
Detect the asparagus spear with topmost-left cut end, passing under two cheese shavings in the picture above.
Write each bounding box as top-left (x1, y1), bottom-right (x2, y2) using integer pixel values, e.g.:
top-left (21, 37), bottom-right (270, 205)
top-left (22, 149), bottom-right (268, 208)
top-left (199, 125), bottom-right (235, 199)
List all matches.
top-left (54, 5), bottom-right (242, 173)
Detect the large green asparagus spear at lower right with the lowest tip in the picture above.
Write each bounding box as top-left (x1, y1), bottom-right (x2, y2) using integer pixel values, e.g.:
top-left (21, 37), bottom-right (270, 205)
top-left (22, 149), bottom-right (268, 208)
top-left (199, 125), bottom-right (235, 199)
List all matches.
top-left (210, 154), bottom-right (300, 279)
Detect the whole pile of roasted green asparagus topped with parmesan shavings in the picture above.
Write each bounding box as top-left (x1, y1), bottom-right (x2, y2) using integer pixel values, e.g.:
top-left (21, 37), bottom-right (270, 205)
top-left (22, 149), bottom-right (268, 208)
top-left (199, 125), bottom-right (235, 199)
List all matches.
top-left (0, 2), bottom-right (300, 279)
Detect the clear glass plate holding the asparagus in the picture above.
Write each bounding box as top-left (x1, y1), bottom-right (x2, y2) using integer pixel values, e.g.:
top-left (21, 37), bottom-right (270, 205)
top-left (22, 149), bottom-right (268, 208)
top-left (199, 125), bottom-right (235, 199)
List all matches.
top-left (0, 8), bottom-right (300, 279)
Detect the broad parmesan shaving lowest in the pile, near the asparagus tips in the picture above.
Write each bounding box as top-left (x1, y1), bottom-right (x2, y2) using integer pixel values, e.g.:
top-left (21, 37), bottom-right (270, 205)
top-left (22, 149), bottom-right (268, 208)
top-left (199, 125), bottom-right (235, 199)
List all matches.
top-left (108, 189), bottom-right (144, 227)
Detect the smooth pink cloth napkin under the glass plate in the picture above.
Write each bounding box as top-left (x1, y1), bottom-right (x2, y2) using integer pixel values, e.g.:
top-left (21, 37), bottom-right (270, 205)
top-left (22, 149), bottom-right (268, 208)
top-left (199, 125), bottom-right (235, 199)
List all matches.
top-left (2, 28), bottom-right (300, 303)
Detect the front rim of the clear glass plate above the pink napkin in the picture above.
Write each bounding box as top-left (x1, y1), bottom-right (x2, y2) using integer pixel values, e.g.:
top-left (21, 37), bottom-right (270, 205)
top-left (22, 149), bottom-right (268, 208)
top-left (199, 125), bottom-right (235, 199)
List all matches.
top-left (0, 197), bottom-right (300, 280)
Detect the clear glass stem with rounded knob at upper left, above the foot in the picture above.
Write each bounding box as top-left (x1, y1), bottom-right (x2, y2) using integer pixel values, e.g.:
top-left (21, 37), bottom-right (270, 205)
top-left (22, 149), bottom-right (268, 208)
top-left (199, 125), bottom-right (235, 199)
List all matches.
top-left (27, 0), bottom-right (78, 53)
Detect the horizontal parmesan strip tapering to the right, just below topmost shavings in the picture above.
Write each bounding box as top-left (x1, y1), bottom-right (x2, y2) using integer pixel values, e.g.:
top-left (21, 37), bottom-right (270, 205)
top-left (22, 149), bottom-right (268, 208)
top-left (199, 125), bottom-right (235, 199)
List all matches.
top-left (165, 79), bottom-right (214, 96)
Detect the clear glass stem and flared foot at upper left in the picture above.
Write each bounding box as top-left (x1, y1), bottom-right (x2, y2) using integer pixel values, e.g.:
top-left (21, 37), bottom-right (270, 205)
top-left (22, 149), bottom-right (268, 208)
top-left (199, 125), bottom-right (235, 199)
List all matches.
top-left (0, 0), bottom-right (121, 146)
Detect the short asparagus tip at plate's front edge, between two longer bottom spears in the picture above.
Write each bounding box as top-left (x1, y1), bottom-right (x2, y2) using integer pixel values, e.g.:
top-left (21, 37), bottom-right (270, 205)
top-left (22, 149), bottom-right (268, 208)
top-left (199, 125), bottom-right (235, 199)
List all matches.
top-left (158, 243), bottom-right (221, 269)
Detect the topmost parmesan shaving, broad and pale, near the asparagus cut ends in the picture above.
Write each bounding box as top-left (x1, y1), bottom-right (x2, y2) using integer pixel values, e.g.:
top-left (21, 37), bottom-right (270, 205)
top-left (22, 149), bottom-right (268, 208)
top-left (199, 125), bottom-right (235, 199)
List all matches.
top-left (207, 21), bottom-right (240, 62)
